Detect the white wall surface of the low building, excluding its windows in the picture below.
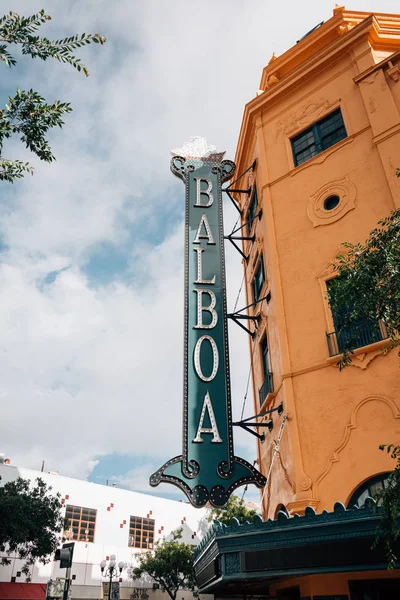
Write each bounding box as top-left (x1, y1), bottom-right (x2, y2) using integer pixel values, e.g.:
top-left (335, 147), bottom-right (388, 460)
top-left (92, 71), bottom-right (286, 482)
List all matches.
top-left (0, 464), bottom-right (212, 598)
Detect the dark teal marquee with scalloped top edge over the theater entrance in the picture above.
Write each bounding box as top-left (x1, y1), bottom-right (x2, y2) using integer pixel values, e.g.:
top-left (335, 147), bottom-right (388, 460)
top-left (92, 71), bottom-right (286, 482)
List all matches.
top-left (195, 498), bottom-right (400, 594)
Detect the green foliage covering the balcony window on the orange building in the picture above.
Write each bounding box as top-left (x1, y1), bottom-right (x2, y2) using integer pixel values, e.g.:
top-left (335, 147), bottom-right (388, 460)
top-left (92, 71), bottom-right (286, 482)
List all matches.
top-left (329, 204), bottom-right (400, 368)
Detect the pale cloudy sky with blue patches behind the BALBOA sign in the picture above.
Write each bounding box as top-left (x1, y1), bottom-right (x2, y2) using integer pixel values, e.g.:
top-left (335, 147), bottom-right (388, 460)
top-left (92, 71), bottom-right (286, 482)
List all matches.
top-left (0, 0), bottom-right (398, 500)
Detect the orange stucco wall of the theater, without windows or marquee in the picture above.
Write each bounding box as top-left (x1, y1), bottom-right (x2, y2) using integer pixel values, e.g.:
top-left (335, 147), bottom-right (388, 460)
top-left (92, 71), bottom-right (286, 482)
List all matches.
top-left (236, 8), bottom-right (400, 518)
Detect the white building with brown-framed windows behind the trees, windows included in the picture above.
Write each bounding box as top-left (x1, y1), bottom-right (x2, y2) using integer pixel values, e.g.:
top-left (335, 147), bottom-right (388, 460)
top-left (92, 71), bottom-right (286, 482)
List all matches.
top-left (0, 464), bottom-right (210, 600)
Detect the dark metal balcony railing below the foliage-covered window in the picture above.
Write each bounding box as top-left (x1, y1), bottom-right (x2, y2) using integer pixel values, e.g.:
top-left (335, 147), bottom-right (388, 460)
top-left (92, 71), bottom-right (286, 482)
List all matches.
top-left (326, 321), bottom-right (388, 356)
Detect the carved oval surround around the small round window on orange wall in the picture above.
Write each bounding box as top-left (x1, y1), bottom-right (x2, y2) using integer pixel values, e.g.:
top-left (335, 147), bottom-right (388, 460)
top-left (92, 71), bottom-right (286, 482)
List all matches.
top-left (307, 177), bottom-right (357, 227)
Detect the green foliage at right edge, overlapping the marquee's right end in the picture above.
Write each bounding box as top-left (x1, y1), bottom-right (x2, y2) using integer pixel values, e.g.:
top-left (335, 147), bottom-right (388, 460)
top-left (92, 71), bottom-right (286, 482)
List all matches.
top-left (374, 444), bottom-right (400, 569)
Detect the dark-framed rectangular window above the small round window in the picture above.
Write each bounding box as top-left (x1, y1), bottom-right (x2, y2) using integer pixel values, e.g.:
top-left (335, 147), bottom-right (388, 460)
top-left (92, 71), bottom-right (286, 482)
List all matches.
top-left (290, 107), bottom-right (348, 167)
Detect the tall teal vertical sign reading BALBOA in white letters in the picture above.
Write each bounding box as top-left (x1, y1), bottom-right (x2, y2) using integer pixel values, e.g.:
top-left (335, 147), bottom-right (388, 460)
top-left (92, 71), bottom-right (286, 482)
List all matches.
top-left (150, 138), bottom-right (266, 507)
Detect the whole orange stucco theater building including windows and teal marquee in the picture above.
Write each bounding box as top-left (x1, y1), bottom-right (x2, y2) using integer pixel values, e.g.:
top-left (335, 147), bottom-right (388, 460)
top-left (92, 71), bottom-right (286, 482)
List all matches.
top-left (196, 7), bottom-right (400, 600)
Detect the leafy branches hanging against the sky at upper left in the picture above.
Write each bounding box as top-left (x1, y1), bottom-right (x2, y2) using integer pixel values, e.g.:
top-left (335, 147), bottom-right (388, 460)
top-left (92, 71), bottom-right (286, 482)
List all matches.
top-left (0, 10), bottom-right (106, 183)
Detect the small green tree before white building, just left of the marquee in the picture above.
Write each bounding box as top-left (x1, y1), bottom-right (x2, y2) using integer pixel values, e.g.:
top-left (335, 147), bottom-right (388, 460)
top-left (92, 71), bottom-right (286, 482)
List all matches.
top-left (132, 529), bottom-right (196, 600)
